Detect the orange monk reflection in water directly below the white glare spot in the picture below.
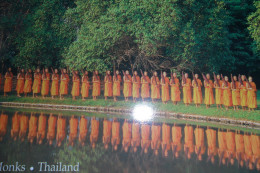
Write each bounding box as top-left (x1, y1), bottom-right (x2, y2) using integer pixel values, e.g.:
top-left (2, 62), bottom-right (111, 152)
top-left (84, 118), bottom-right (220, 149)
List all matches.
top-left (141, 124), bottom-right (151, 153)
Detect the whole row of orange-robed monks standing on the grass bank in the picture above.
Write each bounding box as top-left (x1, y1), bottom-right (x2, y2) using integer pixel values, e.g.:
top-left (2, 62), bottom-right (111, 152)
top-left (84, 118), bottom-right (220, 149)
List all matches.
top-left (1, 68), bottom-right (257, 110)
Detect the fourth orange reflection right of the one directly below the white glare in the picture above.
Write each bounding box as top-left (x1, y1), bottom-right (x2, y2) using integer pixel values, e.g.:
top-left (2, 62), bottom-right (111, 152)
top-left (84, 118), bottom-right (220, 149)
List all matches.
top-left (184, 125), bottom-right (194, 159)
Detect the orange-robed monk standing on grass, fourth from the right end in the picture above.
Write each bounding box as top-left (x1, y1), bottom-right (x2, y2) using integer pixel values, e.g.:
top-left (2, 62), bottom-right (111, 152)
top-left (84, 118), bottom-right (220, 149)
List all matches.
top-left (222, 76), bottom-right (232, 110)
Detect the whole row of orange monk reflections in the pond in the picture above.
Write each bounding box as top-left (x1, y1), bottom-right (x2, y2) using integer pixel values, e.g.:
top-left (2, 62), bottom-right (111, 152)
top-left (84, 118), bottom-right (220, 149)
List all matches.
top-left (0, 112), bottom-right (260, 169)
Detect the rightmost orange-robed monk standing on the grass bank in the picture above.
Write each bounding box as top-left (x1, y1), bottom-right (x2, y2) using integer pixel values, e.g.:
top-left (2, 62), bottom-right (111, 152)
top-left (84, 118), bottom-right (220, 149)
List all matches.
top-left (246, 76), bottom-right (257, 111)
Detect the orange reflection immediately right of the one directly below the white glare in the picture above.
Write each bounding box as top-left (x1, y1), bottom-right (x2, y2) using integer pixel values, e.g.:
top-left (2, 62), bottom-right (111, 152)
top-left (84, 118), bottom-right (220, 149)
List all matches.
top-left (151, 123), bottom-right (161, 156)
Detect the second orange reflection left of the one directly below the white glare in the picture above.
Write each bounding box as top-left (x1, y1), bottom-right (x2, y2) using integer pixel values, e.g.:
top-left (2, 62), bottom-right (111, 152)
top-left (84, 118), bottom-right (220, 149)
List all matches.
top-left (122, 119), bottom-right (132, 152)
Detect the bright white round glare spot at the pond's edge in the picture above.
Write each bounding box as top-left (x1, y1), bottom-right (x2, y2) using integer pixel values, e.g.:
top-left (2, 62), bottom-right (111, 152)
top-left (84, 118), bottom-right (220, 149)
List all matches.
top-left (133, 104), bottom-right (153, 121)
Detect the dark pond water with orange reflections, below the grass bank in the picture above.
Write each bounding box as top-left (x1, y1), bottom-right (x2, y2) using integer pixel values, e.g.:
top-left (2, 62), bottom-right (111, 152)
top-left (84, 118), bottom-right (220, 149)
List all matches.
top-left (0, 110), bottom-right (260, 173)
